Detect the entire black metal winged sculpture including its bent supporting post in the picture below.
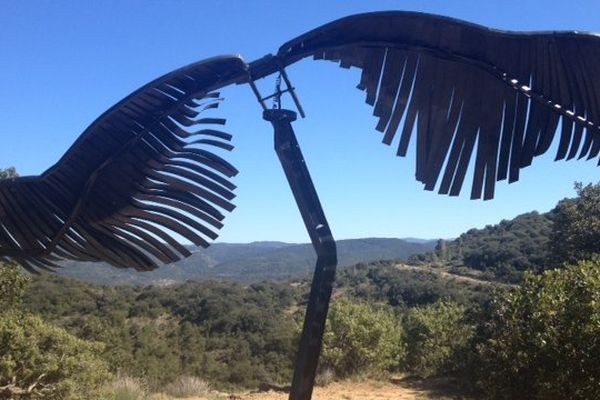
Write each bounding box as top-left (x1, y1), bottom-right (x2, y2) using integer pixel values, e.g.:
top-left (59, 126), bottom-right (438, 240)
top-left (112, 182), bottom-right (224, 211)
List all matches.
top-left (0, 11), bottom-right (600, 400)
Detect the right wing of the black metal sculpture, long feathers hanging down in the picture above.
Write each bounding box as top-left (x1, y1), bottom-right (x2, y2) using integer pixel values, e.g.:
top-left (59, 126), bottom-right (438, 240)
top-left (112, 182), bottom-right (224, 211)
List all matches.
top-left (278, 12), bottom-right (600, 199)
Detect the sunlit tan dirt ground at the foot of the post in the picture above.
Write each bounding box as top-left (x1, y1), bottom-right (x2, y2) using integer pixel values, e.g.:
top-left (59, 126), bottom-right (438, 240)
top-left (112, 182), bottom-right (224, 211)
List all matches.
top-left (195, 379), bottom-right (465, 400)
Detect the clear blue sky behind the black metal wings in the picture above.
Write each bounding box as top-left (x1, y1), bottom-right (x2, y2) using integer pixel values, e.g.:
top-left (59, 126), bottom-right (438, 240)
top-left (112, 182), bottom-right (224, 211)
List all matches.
top-left (0, 0), bottom-right (600, 242)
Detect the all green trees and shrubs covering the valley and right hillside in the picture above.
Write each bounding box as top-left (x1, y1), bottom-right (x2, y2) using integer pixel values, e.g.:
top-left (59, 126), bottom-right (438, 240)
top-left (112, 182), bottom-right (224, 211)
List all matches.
top-left (0, 170), bottom-right (600, 400)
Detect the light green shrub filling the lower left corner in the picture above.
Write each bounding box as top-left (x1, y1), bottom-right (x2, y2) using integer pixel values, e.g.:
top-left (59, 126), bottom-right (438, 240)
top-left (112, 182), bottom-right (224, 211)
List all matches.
top-left (0, 312), bottom-right (110, 399)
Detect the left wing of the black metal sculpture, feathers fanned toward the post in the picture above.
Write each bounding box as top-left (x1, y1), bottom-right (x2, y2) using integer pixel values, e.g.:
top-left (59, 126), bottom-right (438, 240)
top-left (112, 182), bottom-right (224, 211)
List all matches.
top-left (0, 56), bottom-right (247, 270)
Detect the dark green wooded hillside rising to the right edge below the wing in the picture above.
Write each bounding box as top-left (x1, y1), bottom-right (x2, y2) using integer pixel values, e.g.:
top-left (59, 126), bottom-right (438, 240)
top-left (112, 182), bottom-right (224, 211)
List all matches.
top-left (410, 183), bottom-right (600, 283)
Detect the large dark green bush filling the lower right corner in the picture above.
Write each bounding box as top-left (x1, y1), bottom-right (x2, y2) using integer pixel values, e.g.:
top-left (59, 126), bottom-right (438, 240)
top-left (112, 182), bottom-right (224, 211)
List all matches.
top-left (473, 258), bottom-right (600, 399)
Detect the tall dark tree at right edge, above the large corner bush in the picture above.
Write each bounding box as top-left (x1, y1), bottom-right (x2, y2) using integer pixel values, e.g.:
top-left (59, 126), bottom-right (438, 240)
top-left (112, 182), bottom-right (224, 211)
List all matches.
top-left (550, 182), bottom-right (600, 266)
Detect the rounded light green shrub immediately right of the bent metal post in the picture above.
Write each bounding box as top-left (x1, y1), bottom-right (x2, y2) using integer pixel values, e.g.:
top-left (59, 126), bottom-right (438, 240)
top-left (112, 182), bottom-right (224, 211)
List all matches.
top-left (321, 299), bottom-right (404, 377)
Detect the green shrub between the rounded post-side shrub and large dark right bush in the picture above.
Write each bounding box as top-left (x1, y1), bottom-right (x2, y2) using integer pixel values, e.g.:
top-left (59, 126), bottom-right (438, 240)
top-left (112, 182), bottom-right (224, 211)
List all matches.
top-left (404, 301), bottom-right (474, 378)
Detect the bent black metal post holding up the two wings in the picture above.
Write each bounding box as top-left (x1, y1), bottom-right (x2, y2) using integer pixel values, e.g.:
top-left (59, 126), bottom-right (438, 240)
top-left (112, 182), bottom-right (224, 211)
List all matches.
top-left (263, 109), bottom-right (337, 400)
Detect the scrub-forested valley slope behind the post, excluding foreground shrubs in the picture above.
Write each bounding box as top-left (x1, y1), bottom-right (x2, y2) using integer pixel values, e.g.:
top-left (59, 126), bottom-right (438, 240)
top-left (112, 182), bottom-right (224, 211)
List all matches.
top-left (19, 262), bottom-right (492, 387)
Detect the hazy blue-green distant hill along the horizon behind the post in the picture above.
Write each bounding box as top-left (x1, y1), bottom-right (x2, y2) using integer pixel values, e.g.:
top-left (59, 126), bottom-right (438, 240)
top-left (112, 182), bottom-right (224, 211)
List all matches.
top-left (59, 238), bottom-right (436, 285)
